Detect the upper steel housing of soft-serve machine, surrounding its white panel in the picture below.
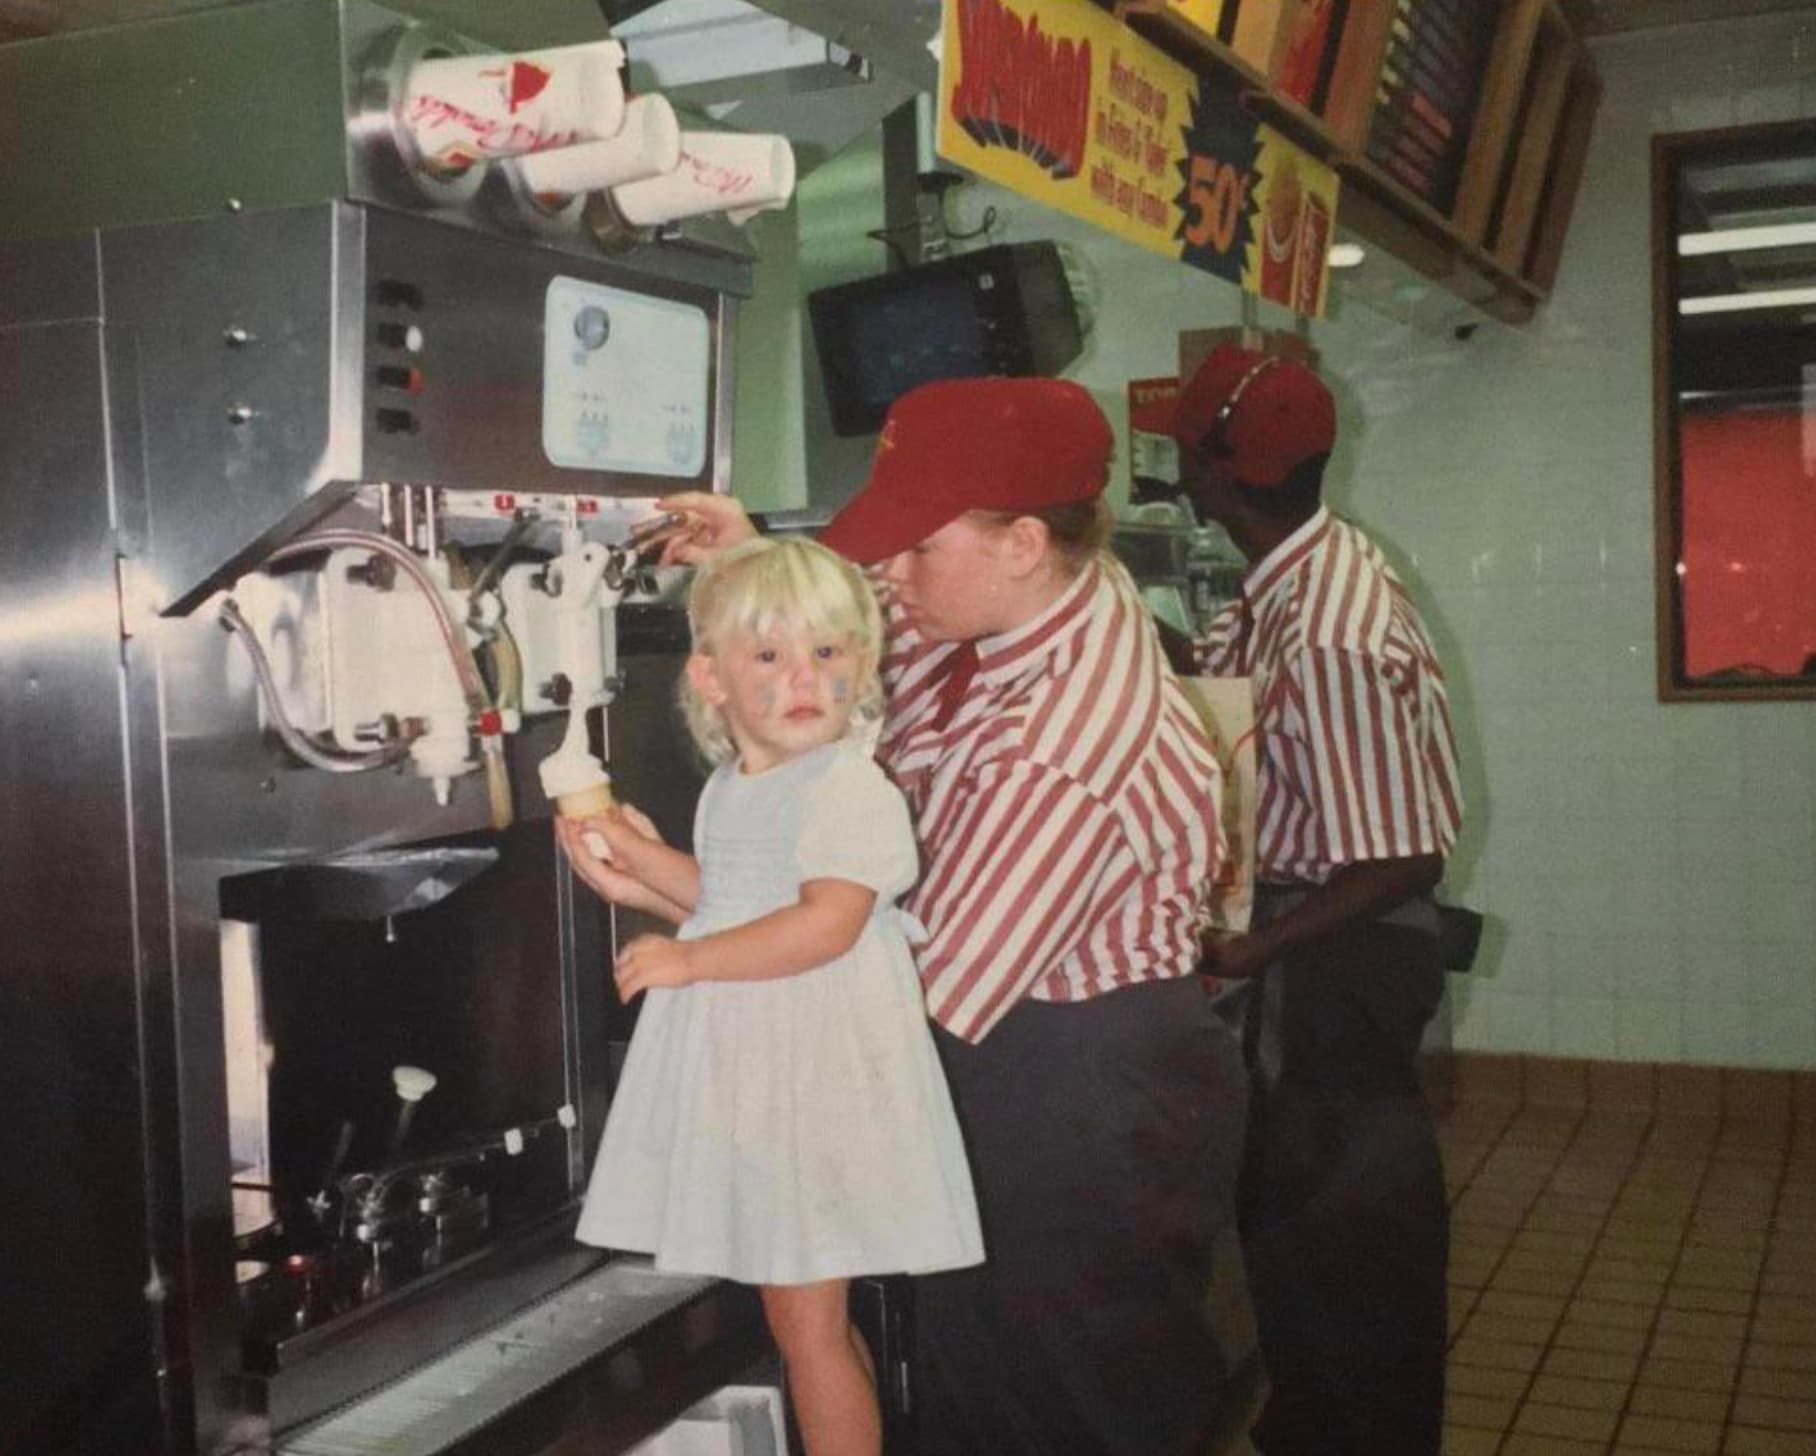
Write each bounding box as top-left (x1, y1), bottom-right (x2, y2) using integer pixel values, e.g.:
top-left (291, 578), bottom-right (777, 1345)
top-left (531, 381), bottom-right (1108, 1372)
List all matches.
top-left (101, 203), bottom-right (728, 612)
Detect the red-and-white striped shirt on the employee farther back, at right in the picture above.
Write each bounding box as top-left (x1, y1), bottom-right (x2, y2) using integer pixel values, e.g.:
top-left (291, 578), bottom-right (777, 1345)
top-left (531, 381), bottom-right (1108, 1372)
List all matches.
top-left (1199, 507), bottom-right (1462, 884)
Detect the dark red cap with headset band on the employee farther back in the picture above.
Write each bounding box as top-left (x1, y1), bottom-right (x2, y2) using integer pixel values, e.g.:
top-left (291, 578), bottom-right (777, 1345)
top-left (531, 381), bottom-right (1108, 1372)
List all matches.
top-left (1173, 343), bottom-right (1337, 485)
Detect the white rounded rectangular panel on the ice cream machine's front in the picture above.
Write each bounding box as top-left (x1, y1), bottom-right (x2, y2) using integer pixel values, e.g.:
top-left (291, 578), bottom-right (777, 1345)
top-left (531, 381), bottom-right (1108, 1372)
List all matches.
top-left (543, 276), bottom-right (712, 479)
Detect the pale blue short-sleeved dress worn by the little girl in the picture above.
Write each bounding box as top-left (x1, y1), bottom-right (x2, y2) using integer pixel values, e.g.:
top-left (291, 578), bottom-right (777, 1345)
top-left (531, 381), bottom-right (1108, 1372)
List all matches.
top-left (577, 743), bottom-right (982, 1284)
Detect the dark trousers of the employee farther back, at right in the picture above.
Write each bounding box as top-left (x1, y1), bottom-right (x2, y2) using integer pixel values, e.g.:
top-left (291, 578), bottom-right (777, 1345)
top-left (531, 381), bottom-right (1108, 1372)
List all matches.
top-left (1242, 907), bottom-right (1449, 1456)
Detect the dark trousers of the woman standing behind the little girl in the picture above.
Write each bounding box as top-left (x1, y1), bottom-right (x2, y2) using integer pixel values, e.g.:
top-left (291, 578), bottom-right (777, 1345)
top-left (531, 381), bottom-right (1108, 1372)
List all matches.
top-left (913, 979), bottom-right (1246, 1456)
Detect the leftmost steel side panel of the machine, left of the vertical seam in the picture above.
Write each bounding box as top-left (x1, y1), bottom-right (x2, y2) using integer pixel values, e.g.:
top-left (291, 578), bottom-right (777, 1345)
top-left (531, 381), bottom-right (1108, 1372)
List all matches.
top-left (0, 314), bottom-right (165, 1452)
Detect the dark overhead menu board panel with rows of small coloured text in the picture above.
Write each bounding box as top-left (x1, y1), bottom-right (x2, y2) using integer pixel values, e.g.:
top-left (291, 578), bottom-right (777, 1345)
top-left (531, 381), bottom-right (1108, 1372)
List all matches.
top-left (1366, 0), bottom-right (1500, 212)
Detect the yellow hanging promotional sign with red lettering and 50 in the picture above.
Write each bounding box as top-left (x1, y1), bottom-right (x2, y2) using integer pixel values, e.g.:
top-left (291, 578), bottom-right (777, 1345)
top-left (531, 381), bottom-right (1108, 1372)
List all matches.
top-left (939, 0), bottom-right (1337, 314)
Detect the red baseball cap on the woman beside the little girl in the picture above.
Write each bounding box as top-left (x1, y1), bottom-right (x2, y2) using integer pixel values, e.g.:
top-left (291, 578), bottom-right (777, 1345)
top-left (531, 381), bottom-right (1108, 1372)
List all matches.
top-left (819, 376), bottom-right (1111, 566)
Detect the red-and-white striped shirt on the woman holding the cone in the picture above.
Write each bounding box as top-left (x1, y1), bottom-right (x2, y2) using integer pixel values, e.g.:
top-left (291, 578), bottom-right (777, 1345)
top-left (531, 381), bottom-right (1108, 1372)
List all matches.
top-left (877, 556), bottom-right (1219, 1042)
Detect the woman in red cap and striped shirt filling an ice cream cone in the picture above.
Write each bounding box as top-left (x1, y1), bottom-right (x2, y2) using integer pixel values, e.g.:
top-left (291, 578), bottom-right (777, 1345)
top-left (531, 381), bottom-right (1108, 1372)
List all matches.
top-left (563, 379), bottom-right (1244, 1456)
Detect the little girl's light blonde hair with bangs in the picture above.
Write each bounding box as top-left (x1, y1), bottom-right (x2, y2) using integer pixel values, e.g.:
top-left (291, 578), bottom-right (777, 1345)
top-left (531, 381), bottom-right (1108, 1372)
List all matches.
top-left (679, 536), bottom-right (883, 764)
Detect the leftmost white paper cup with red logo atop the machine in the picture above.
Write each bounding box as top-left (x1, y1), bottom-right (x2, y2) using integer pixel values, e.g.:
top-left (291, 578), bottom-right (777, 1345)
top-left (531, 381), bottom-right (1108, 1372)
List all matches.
top-left (403, 40), bottom-right (625, 172)
